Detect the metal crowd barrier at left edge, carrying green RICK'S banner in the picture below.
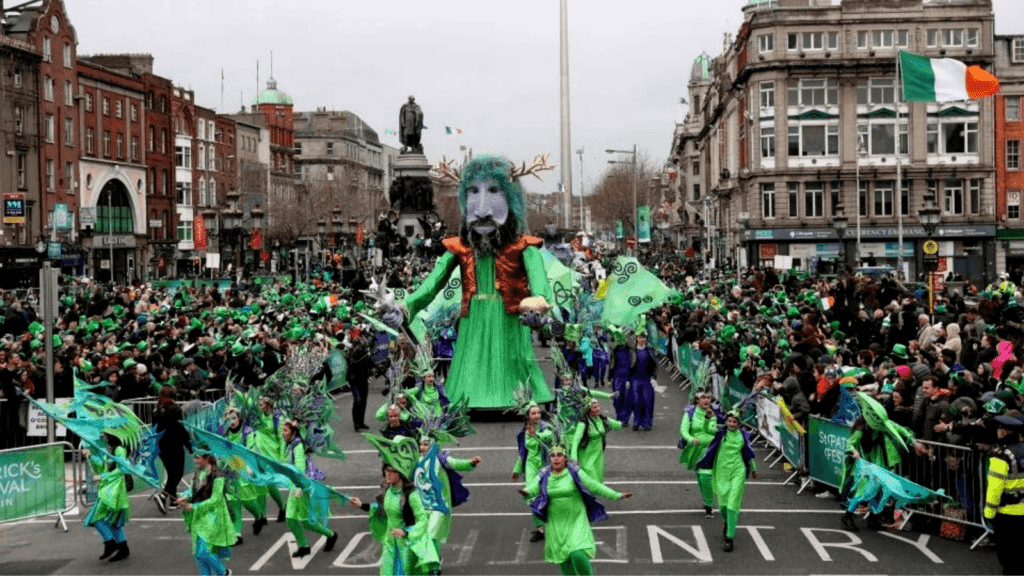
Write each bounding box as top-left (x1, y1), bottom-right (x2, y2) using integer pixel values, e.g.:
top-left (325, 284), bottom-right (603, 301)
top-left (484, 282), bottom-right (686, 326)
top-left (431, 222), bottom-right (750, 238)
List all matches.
top-left (0, 442), bottom-right (80, 532)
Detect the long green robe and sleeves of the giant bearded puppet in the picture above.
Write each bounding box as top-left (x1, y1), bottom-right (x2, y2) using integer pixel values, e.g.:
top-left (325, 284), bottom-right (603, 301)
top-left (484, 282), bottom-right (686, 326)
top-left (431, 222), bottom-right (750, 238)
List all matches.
top-left (406, 251), bottom-right (553, 408)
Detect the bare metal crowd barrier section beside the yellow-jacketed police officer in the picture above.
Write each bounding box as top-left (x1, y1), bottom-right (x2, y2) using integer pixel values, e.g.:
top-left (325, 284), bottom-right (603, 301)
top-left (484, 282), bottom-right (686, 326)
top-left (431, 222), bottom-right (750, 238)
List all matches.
top-left (899, 441), bottom-right (989, 549)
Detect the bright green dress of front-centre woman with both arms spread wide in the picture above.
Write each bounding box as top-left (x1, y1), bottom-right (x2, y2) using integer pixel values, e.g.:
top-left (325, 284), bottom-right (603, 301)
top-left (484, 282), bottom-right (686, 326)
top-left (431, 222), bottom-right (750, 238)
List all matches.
top-left (526, 467), bottom-right (623, 574)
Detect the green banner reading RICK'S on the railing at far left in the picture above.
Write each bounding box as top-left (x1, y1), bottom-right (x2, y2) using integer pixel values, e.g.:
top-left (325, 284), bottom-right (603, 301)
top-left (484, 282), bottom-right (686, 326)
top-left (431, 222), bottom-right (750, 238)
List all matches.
top-left (0, 444), bottom-right (65, 523)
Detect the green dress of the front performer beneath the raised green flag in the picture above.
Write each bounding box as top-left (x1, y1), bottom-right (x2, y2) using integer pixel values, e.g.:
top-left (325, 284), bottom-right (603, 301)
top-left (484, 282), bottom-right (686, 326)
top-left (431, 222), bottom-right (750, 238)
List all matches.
top-left (362, 486), bottom-right (439, 576)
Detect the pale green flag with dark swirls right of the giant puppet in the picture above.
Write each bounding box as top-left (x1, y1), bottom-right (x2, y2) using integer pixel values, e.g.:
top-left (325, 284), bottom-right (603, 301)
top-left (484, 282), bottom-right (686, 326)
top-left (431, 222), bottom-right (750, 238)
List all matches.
top-left (601, 256), bottom-right (673, 326)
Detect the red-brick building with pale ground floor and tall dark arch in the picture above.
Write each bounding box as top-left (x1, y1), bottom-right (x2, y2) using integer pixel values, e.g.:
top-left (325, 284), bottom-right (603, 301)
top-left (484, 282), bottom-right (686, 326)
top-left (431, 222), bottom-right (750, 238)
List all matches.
top-left (78, 56), bottom-right (148, 282)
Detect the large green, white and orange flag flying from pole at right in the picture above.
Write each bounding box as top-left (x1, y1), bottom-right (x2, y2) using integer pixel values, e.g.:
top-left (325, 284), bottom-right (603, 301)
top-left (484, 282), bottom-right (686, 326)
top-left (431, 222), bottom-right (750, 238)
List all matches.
top-left (899, 51), bottom-right (999, 102)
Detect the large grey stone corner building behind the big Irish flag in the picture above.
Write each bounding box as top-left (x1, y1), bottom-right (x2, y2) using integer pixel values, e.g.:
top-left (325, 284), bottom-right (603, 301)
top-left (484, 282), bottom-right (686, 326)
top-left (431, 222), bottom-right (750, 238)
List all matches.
top-left (670, 0), bottom-right (995, 282)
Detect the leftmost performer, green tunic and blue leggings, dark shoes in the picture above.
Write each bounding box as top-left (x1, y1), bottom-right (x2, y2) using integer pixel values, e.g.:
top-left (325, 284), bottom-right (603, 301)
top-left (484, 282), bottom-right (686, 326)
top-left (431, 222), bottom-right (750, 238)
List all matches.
top-left (82, 434), bottom-right (131, 562)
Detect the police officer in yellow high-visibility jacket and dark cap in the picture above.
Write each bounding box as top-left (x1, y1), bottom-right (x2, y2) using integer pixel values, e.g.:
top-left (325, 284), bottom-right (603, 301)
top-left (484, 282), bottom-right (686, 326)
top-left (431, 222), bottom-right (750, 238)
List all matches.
top-left (985, 413), bottom-right (1024, 574)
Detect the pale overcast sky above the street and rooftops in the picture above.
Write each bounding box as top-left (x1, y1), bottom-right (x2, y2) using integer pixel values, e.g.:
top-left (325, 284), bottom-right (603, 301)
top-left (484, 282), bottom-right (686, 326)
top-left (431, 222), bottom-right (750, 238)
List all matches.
top-left (65, 0), bottom-right (1024, 193)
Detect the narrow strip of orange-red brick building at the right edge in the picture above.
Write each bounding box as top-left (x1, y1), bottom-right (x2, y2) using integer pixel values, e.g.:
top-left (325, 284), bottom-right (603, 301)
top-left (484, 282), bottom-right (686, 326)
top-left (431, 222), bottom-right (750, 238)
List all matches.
top-left (995, 35), bottom-right (1024, 280)
